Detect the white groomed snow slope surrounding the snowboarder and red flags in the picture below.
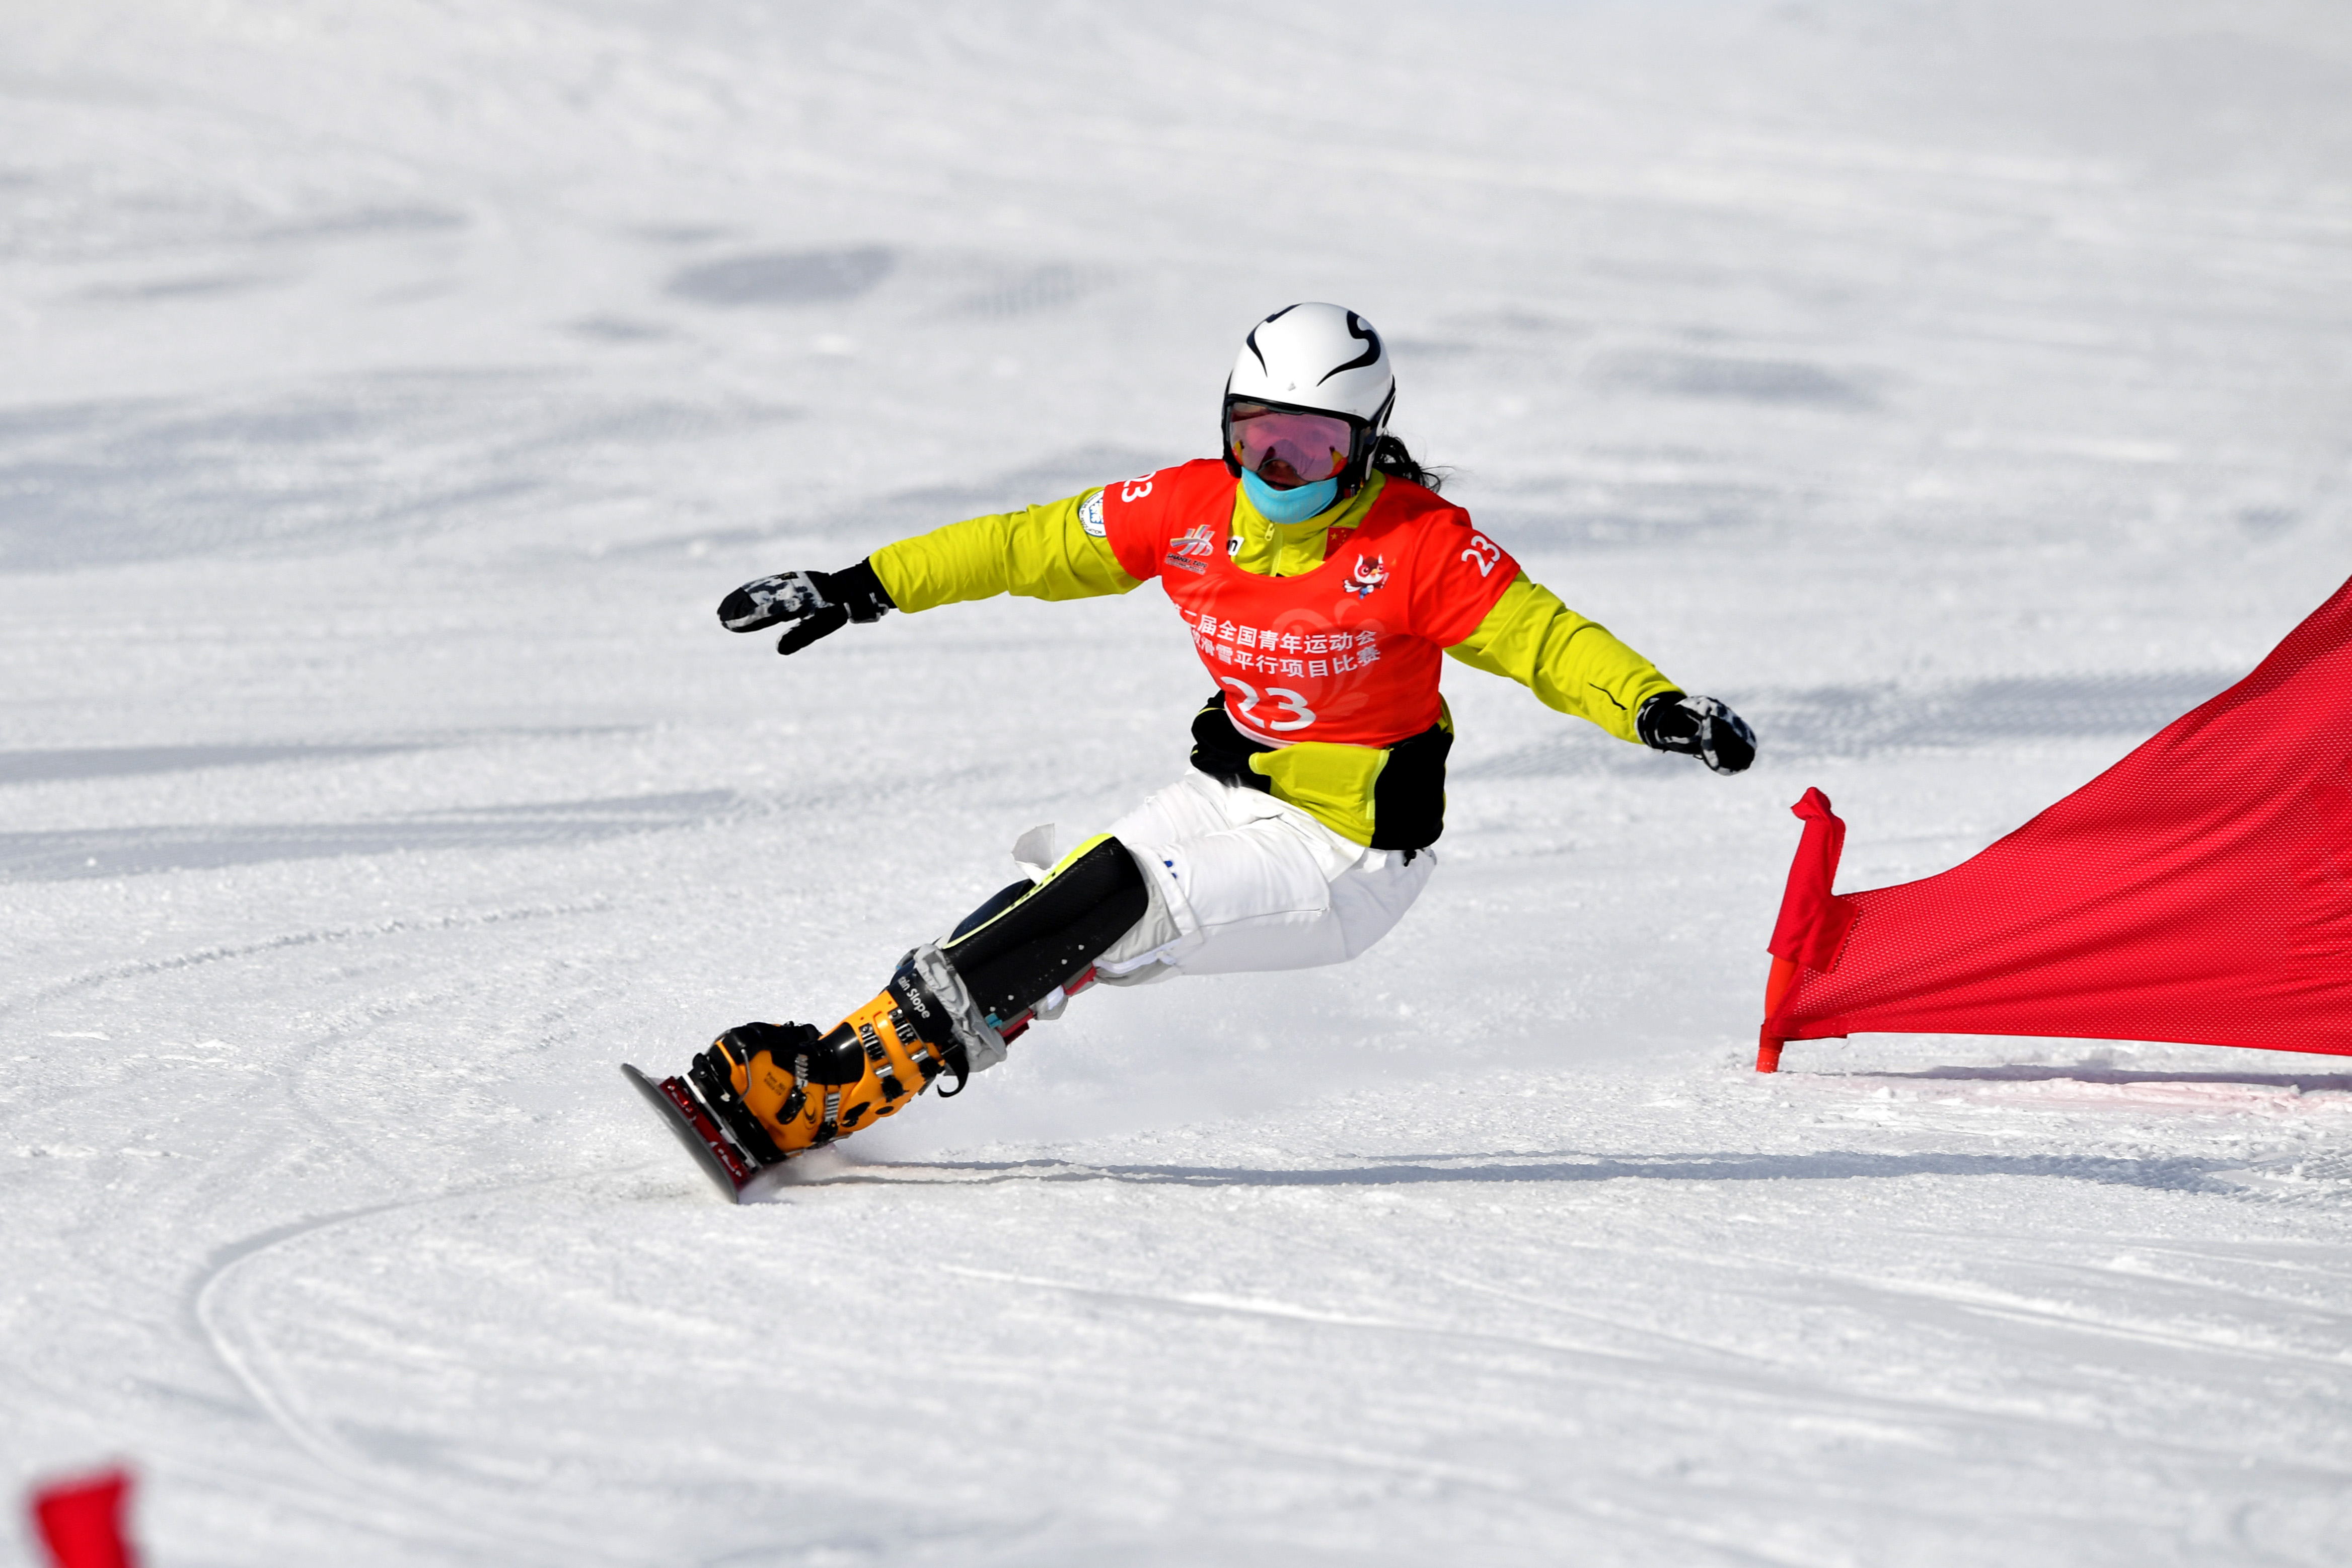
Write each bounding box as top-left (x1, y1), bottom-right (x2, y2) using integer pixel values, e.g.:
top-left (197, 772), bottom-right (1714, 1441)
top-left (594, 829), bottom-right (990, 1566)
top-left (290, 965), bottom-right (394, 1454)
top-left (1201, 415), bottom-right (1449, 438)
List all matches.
top-left (0, 0), bottom-right (2352, 1568)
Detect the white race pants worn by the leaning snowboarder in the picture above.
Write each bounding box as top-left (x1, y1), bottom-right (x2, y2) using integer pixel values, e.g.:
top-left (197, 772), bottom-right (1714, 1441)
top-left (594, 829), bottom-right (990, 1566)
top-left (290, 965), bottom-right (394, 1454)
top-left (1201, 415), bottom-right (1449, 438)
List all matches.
top-left (1014, 771), bottom-right (1437, 985)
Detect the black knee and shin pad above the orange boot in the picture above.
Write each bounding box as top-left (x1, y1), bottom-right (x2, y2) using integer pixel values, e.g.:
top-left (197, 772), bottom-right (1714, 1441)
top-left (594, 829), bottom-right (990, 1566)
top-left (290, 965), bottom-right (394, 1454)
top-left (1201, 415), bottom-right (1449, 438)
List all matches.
top-left (941, 837), bottom-right (1150, 1020)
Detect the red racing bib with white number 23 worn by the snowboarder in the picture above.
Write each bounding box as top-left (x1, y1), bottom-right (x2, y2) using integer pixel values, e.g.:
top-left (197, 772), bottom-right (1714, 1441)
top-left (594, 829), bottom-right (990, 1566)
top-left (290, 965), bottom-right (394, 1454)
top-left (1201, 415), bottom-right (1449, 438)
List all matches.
top-left (1103, 459), bottom-right (1519, 748)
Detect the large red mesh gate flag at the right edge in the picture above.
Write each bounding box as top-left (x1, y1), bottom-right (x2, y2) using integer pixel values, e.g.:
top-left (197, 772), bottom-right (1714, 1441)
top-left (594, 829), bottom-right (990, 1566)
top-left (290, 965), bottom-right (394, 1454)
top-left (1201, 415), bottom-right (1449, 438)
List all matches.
top-left (1757, 583), bottom-right (2352, 1072)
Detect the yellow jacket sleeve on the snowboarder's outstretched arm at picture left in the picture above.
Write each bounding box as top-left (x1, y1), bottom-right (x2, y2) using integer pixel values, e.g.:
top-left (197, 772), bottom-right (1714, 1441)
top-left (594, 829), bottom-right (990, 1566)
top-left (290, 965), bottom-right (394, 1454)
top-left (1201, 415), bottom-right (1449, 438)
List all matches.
top-left (872, 489), bottom-right (1138, 611)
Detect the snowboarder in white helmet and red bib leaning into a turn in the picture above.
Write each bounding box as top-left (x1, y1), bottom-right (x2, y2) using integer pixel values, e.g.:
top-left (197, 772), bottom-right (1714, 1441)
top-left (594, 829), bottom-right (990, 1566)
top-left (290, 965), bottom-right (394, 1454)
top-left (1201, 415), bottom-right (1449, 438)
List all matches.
top-left (640, 303), bottom-right (1754, 1189)
